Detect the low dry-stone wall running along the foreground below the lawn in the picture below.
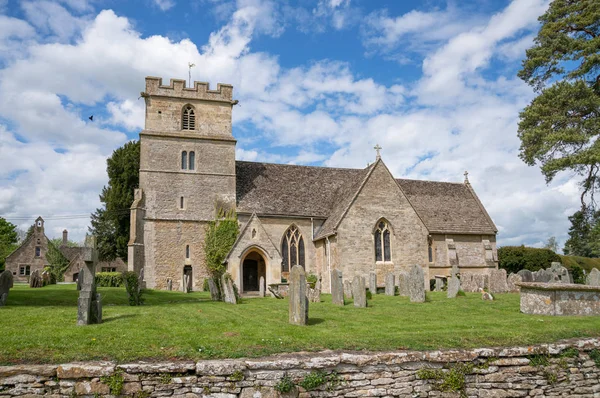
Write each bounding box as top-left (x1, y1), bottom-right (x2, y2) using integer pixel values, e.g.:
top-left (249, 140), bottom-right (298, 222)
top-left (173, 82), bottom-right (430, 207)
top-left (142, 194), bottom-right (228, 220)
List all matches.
top-left (0, 339), bottom-right (600, 398)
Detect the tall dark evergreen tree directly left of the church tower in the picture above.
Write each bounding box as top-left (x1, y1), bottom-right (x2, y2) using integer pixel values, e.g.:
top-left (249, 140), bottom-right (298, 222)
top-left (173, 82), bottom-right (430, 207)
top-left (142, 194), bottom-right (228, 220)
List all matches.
top-left (89, 141), bottom-right (140, 260)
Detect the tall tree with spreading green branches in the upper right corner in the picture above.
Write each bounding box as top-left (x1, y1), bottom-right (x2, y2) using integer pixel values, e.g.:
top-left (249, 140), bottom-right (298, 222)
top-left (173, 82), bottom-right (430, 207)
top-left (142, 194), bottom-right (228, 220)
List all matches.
top-left (519, 0), bottom-right (600, 207)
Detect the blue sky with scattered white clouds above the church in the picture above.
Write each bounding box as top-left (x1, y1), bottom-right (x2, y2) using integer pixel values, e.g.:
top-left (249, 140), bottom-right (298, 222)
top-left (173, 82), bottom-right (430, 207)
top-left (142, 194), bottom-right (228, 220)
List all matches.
top-left (0, 0), bottom-right (578, 246)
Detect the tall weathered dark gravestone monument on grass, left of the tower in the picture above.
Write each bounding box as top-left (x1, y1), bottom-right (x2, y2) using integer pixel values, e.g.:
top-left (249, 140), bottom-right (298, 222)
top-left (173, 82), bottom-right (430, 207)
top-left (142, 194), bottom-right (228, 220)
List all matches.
top-left (77, 236), bottom-right (102, 326)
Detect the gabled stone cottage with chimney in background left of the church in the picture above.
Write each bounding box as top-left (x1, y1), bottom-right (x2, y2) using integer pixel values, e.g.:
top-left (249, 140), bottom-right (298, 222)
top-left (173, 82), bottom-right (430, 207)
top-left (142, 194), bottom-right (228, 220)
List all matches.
top-left (6, 217), bottom-right (127, 282)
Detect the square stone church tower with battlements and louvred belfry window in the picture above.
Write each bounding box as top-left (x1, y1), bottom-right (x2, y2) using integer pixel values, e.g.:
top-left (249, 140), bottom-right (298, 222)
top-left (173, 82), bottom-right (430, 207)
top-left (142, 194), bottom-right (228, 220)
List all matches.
top-left (128, 77), bottom-right (237, 290)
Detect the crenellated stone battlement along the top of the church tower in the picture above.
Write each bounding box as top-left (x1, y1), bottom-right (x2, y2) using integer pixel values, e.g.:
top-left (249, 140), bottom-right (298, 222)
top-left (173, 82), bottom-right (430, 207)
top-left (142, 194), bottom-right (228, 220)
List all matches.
top-left (145, 76), bottom-right (233, 102)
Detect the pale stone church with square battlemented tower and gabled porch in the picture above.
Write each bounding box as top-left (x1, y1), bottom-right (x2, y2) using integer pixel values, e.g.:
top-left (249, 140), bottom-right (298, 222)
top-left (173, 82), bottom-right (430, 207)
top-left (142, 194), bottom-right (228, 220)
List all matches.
top-left (128, 77), bottom-right (498, 294)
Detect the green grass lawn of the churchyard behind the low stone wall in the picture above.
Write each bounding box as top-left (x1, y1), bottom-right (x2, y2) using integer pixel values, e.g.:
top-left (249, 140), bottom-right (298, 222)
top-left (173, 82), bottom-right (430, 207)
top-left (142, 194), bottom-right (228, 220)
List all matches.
top-left (0, 285), bottom-right (600, 364)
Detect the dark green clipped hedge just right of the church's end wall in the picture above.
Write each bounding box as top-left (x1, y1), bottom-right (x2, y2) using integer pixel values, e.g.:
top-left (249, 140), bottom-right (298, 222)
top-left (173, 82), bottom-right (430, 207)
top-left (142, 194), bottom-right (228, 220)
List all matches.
top-left (498, 246), bottom-right (562, 273)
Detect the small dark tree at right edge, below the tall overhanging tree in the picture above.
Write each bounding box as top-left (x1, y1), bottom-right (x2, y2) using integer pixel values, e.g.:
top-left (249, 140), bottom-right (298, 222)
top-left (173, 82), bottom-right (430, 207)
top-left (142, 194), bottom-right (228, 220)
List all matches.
top-left (563, 208), bottom-right (600, 257)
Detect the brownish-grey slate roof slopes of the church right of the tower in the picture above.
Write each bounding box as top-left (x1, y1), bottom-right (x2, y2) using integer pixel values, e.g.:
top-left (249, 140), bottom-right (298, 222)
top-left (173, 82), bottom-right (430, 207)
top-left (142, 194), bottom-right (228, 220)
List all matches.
top-left (236, 161), bottom-right (497, 238)
